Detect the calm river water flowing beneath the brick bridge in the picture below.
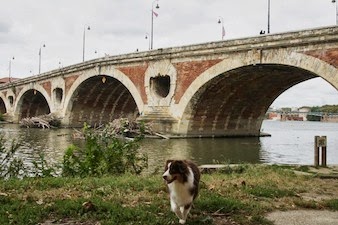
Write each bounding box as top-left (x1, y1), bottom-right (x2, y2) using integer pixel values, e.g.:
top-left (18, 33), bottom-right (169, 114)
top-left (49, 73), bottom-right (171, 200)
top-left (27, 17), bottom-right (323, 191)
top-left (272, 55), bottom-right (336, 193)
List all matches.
top-left (0, 120), bottom-right (338, 172)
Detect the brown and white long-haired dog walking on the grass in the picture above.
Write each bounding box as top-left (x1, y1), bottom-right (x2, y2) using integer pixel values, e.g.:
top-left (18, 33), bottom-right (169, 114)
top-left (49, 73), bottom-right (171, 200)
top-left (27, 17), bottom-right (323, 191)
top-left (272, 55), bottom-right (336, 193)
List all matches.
top-left (163, 160), bottom-right (201, 224)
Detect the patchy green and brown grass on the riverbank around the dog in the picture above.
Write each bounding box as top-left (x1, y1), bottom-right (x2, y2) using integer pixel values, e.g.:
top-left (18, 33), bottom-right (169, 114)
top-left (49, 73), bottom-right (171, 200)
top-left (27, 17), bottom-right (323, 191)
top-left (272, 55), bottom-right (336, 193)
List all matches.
top-left (0, 165), bottom-right (338, 225)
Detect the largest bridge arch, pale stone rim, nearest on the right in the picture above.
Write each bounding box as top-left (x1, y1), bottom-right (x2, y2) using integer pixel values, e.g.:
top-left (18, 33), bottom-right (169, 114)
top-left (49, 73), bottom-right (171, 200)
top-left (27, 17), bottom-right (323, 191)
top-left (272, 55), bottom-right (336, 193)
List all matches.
top-left (174, 50), bottom-right (338, 136)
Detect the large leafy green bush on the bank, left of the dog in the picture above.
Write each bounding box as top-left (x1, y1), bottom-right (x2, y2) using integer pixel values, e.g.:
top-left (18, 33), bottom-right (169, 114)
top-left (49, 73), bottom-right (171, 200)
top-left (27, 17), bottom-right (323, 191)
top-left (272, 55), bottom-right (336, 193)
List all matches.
top-left (62, 124), bottom-right (148, 177)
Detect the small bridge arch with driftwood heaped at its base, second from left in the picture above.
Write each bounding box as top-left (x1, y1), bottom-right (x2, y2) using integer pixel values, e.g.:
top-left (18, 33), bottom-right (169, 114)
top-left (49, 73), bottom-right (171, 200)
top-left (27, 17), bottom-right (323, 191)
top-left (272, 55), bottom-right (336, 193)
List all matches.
top-left (14, 83), bottom-right (53, 121)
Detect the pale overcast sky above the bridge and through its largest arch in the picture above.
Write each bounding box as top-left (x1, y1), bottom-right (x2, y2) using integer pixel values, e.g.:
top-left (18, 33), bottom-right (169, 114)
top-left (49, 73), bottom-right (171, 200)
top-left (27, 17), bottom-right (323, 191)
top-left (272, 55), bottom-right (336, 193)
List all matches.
top-left (0, 0), bottom-right (338, 107)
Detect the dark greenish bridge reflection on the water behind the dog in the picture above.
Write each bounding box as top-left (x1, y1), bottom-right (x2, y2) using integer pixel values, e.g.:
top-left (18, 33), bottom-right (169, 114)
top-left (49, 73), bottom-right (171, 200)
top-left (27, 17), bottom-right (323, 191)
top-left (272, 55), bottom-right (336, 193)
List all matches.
top-left (142, 138), bottom-right (261, 171)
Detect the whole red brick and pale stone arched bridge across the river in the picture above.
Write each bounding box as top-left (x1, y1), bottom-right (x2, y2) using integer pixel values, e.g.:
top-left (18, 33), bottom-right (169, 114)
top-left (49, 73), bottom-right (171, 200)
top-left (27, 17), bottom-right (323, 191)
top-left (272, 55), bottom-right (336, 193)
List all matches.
top-left (0, 26), bottom-right (338, 137)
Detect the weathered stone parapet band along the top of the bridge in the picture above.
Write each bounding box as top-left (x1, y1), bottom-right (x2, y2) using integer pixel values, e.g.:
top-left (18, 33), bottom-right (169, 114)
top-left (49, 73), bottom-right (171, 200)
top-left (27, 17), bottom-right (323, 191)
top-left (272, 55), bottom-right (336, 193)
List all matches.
top-left (0, 26), bottom-right (338, 90)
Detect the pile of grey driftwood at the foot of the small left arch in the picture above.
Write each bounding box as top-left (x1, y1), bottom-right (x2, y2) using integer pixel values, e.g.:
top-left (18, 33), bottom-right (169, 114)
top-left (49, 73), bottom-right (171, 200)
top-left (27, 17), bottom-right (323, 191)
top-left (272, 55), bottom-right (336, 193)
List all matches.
top-left (20, 114), bottom-right (60, 129)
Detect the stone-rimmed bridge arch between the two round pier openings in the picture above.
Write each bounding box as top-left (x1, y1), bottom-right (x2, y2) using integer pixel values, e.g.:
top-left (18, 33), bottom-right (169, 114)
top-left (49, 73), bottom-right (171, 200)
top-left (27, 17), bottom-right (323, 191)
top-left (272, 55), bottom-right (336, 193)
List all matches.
top-left (63, 66), bottom-right (144, 126)
